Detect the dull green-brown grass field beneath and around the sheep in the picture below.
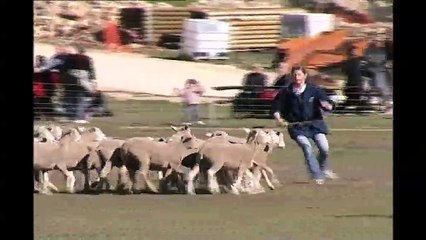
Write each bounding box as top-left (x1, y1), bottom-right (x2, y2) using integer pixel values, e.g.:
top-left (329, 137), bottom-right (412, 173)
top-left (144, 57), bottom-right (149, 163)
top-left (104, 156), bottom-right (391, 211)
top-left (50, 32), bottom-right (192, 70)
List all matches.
top-left (34, 100), bottom-right (393, 240)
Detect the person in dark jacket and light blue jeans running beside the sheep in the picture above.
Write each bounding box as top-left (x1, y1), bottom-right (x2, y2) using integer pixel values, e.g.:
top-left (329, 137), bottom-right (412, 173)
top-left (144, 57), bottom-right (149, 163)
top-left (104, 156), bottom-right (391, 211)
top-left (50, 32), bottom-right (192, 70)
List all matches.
top-left (272, 66), bottom-right (338, 184)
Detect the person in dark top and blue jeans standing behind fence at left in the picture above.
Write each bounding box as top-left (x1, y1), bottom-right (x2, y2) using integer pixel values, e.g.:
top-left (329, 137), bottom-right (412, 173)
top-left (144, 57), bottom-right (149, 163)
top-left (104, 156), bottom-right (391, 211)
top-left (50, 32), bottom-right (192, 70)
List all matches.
top-left (69, 47), bottom-right (96, 123)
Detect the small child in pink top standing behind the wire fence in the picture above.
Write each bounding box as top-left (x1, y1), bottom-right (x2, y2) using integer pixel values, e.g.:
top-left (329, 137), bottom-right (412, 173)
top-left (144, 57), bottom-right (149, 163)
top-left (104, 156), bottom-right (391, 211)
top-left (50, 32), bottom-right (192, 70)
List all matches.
top-left (174, 79), bottom-right (205, 125)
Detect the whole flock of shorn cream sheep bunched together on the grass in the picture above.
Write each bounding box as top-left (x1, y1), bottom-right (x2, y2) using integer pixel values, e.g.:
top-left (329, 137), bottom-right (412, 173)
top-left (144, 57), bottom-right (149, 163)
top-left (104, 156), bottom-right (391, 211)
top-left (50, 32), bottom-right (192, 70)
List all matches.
top-left (34, 125), bottom-right (285, 194)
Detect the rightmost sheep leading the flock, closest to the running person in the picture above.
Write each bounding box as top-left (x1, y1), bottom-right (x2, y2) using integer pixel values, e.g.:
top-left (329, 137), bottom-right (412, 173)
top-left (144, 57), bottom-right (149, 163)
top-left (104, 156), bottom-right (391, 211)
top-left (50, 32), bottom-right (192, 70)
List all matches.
top-left (187, 129), bottom-right (285, 194)
